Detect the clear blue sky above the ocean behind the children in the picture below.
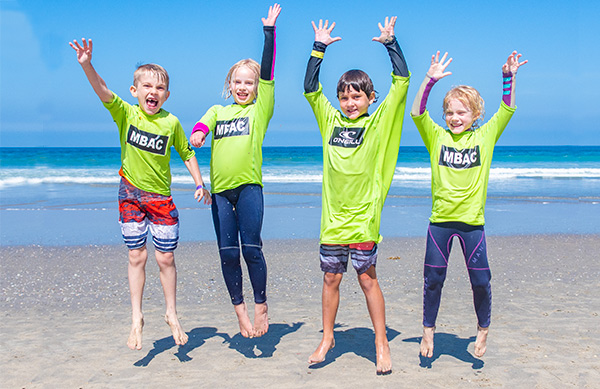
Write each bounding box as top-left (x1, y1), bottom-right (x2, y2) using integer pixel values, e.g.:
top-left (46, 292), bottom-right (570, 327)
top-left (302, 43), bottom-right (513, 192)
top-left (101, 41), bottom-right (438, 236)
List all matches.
top-left (0, 0), bottom-right (600, 147)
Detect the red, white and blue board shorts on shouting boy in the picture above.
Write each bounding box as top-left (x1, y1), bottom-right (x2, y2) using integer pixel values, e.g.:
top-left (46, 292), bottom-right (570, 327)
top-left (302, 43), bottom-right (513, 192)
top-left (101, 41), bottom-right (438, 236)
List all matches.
top-left (119, 177), bottom-right (179, 252)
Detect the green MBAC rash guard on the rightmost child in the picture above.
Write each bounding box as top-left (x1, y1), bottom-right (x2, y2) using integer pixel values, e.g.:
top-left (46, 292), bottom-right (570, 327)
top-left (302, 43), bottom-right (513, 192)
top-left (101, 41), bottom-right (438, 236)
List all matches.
top-left (413, 102), bottom-right (515, 226)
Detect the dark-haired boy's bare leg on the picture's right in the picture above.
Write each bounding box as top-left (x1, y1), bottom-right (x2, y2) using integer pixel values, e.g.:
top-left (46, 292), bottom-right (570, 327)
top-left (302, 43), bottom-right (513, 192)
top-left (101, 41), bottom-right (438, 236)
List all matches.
top-left (358, 266), bottom-right (392, 375)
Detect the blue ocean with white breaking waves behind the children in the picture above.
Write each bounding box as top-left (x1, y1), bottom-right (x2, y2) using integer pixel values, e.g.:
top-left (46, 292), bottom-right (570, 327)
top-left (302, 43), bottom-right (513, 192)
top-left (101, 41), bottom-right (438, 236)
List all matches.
top-left (0, 146), bottom-right (600, 246)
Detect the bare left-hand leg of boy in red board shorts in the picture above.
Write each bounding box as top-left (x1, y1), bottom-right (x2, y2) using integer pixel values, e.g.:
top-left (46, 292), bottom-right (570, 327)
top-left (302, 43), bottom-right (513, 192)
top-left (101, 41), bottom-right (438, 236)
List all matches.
top-left (127, 246), bottom-right (148, 350)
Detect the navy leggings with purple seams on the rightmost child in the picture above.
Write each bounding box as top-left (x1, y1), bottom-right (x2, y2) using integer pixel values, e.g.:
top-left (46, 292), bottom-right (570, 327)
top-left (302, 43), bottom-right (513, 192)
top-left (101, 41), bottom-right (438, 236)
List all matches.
top-left (423, 222), bottom-right (492, 328)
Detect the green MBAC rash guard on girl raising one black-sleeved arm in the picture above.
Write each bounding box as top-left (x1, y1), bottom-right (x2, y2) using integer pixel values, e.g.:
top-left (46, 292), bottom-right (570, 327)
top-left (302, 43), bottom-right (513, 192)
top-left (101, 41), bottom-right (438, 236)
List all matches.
top-left (199, 78), bottom-right (275, 193)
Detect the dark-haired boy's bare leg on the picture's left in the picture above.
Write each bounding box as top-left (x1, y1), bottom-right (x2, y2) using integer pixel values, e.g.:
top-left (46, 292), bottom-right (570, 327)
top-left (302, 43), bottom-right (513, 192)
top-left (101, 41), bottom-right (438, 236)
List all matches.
top-left (308, 273), bottom-right (343, 364)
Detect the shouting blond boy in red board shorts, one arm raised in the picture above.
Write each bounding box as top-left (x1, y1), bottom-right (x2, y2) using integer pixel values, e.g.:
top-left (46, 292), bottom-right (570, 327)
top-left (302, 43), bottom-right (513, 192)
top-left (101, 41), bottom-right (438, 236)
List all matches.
top-left (69, 39), bottom-right (211, 350)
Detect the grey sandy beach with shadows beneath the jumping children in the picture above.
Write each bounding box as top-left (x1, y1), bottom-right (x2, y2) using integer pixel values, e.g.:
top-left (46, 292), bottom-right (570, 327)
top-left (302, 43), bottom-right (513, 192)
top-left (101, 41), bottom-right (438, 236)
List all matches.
top-left (0, 235), bottom-right (600, 388)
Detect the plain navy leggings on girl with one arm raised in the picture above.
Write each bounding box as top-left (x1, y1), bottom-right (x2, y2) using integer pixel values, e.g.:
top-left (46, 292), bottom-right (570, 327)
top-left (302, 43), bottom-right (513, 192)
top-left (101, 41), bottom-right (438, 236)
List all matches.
top-left (212, 184), bottom-right (267, 305)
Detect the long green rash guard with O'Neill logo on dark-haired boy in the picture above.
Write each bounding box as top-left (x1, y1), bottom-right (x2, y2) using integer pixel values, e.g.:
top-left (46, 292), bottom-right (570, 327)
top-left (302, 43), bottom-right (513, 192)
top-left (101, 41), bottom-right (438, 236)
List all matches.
top-left (304, 74), bottom-right (410, 244)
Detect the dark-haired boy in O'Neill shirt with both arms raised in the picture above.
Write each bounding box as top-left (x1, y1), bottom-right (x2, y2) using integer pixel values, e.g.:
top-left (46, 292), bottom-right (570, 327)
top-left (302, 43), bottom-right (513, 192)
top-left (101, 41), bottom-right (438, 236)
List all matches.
top-left (304, 17), bottom-right (409, 374)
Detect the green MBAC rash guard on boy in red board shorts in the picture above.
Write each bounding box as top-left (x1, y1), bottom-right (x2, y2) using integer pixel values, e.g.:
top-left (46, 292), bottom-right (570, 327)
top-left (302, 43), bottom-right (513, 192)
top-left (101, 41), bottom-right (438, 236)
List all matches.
top-left (104, 93), bottom-right (195, 196)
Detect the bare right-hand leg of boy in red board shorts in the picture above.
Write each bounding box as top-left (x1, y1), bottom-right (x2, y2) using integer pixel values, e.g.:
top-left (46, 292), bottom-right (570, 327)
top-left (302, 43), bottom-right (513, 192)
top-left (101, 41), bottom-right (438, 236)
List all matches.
top-left (155, 250), bottom-right (188, 346)
